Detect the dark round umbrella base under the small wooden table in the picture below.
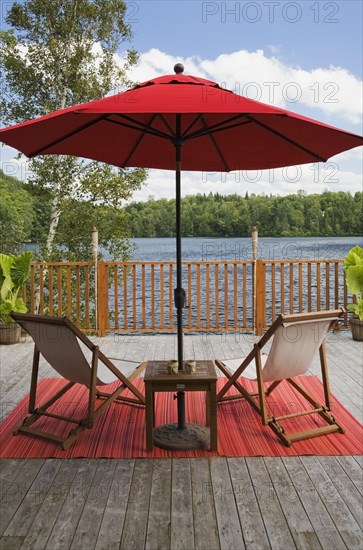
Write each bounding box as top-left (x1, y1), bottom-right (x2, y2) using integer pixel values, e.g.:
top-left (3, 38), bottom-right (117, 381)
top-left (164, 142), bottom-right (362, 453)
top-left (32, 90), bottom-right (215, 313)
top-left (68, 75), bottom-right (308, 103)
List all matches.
top-left (154, 424), bottom-right (210, 451)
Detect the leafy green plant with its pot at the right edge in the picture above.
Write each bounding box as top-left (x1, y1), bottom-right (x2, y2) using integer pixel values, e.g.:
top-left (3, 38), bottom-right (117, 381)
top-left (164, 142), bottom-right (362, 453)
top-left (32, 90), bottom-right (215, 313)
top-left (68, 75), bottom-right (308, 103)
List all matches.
top-left (344, 246), bottom-right (363, 341)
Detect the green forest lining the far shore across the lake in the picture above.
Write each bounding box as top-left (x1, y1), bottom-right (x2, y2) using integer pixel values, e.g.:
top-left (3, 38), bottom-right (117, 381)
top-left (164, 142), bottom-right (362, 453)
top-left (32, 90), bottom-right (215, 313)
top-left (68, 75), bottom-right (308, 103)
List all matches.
top-left (0, 171), bottom-right (363, 259)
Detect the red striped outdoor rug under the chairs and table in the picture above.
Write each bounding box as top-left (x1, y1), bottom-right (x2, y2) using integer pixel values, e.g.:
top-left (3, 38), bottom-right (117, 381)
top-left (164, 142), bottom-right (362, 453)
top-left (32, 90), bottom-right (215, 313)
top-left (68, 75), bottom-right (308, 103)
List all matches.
top-left (0, 376), bottom-right (363, 458)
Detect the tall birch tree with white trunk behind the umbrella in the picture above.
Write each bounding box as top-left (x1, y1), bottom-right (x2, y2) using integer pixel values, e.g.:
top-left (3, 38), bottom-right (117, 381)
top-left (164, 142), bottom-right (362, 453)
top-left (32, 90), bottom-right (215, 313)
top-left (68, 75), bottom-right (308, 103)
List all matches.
top-left (0, 0), bottom-right (146, 260)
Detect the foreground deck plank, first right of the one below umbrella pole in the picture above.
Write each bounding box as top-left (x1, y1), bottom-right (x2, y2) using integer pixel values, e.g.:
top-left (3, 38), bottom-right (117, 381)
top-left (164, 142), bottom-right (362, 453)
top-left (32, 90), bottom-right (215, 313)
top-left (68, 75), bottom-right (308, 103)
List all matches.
top-left (190, 458), bottom-right (220, 550)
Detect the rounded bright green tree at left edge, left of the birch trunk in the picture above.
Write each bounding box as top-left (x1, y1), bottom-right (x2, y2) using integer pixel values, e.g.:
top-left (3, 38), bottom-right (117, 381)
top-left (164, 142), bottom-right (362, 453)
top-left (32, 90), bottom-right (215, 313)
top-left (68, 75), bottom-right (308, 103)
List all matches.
top-left (0, 170), bottom-right (34, 253)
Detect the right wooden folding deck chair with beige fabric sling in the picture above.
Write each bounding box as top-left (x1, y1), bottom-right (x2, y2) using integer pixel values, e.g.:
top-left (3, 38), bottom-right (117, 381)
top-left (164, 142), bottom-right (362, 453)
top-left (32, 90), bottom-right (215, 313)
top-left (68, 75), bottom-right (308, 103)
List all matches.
top-left (215, 309), bottom-right (345, 447)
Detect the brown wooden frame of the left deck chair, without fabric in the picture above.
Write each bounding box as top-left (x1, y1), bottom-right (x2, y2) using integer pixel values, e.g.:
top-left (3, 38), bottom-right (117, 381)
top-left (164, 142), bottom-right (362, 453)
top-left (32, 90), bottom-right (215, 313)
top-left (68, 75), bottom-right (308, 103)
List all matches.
top-left (11, 312), bottom-right (146, 449)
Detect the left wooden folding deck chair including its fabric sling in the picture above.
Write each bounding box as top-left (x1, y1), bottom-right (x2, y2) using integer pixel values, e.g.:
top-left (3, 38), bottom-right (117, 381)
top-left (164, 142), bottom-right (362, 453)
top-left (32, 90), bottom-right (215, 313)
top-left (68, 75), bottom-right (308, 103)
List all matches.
top-left (11, 312), bottom-right (146, 449)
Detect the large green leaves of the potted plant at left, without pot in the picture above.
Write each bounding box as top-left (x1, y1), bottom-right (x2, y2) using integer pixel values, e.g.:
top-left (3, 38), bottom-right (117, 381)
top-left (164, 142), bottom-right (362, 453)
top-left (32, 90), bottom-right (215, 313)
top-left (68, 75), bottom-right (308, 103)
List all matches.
top-left (0, 252), bottom-right (32, 324)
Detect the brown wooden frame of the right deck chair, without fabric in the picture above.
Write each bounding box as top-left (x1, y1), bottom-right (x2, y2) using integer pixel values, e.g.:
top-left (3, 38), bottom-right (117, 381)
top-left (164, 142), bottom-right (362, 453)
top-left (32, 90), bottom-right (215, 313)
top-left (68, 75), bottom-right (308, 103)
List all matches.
top-left (215, 309), bottom-right (345, 447)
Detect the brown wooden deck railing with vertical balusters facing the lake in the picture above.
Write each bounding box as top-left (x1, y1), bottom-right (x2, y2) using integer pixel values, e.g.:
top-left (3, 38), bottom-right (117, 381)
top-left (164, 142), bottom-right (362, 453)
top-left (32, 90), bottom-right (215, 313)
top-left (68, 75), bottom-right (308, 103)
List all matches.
top-left (24, 260), bottom-right (351, 336)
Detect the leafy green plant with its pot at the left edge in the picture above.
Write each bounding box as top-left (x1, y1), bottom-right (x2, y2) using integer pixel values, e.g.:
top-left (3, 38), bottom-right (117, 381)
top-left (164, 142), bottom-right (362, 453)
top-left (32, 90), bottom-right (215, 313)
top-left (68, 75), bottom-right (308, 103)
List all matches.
top-left (0, 251), bottom-right (32, 344)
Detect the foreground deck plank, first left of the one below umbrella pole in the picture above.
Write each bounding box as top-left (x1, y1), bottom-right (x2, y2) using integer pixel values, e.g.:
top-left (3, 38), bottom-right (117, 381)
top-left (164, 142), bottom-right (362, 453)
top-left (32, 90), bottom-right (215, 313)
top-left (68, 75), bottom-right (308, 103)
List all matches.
top-left (145, 458), bottom-right (172, 550)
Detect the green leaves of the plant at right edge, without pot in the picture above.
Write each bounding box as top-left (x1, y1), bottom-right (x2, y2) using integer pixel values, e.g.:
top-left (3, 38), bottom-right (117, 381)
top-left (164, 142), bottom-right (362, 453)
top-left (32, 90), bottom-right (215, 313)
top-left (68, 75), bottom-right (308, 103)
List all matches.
top-left (344, 246), bottom-right (363, 321)
